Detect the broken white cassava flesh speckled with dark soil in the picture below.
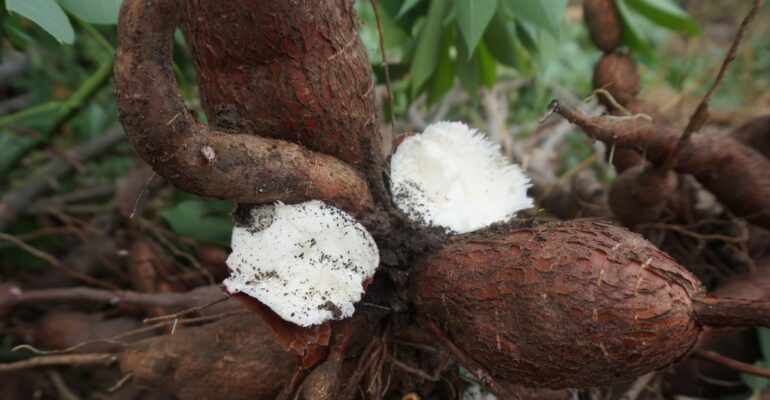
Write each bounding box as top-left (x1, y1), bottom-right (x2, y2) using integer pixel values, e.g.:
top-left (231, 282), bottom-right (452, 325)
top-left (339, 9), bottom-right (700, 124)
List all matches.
top-left (224, 200), bottom-right (380, 326)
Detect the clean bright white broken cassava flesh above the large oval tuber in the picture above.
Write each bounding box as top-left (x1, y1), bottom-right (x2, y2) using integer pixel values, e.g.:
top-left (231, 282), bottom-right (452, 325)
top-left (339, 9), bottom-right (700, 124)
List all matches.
top-left (390, 122), bottom-right (533, 233)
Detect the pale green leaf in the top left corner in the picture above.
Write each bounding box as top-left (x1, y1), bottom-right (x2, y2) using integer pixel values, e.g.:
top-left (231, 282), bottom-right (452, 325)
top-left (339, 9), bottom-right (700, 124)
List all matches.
top-left (5, 0), bottom-right (75, 44)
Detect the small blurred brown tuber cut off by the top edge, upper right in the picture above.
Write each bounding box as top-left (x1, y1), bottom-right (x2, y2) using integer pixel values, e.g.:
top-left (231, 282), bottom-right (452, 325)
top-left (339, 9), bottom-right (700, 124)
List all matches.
top-left (583, 0), bottom-right (623, 53)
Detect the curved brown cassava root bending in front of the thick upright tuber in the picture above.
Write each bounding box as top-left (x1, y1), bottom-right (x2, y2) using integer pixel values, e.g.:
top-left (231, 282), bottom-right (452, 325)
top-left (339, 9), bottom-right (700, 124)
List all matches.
top-left (115, 0), bottom-right (372, 214)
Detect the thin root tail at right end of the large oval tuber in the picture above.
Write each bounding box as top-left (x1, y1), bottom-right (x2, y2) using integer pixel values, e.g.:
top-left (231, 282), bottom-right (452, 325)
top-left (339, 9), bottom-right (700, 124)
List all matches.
top-left (692, 296), bottom-right (770, 328)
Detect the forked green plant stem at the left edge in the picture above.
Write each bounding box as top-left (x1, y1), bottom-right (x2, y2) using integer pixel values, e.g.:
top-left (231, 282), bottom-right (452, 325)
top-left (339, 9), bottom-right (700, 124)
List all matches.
top-left (0, 59), bottom-right (113, 176)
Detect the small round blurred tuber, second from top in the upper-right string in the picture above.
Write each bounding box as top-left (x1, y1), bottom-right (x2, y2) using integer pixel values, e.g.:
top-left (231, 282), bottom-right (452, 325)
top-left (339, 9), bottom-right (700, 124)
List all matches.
top-left (593, 53), bottom-right (639, 107)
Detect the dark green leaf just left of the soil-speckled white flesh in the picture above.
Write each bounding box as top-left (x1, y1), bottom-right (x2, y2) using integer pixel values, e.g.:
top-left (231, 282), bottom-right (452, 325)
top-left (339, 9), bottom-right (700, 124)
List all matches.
top-left (160, 199), bottom-right (233, 244)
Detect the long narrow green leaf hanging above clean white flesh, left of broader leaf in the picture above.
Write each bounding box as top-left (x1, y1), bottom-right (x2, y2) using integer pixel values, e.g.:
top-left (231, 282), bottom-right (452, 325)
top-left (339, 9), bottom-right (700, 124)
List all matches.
top-left (409, 0), bottom-right (449, 96)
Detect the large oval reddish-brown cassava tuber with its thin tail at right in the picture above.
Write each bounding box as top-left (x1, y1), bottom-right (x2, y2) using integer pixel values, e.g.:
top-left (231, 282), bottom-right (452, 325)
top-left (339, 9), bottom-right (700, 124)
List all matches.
top-left (412, 220), bottom-right (770, 388)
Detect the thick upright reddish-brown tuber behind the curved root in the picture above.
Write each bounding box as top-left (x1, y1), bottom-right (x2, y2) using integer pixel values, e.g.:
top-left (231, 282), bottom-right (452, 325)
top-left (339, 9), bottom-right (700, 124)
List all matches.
top-left (181, 0), bottom-right (381, 168)
